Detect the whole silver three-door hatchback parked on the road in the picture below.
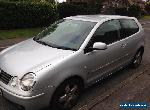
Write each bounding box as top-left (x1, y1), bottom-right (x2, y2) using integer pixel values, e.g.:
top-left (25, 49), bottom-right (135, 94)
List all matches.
top-left (0, 15), bottom-right (144, 110)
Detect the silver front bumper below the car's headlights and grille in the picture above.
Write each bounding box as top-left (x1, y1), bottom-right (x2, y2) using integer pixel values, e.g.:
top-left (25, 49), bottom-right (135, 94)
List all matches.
top-left (0, 86), bottom-right (49, 110)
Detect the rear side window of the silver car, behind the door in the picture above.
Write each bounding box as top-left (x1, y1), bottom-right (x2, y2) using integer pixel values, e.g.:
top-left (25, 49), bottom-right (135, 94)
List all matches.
top-left (120, 19), bottom-right (139, 38)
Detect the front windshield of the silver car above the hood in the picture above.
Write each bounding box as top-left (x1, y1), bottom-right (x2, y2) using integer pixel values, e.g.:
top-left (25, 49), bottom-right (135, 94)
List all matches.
top-left (34, 19), bottom-right (96, 51)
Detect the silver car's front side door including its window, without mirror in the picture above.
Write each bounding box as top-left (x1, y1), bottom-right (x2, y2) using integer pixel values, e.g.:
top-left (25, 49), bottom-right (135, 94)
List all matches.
top-left (84, 20), bottom-right (126, 82)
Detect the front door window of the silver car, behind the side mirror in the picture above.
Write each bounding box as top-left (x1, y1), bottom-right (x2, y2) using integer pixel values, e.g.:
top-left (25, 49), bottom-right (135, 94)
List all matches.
top-left (90, 20), bottom-right (121, 45)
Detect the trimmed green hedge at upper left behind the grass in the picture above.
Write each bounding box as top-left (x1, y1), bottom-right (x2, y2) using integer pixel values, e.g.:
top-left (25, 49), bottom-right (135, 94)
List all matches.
top-left (0, 1), bottom-right (58, 29)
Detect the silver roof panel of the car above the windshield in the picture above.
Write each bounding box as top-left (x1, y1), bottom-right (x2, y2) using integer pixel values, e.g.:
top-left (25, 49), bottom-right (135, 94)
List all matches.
top-left (65, 15), bottom-right (135, 22)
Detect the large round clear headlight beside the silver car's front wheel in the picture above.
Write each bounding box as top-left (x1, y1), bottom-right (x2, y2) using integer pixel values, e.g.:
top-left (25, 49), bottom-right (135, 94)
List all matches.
top-left (20, 73), bottom-right (36, 91)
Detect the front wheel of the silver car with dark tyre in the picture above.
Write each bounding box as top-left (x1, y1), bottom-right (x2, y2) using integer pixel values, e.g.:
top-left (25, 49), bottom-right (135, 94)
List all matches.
top-left (51, 79), bottom-right (83, 110)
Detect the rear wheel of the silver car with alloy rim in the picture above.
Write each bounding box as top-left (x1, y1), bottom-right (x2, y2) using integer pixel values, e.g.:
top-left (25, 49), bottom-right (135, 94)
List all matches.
top-left (131, 49), bottom-right (143, 68)
